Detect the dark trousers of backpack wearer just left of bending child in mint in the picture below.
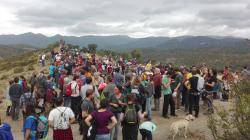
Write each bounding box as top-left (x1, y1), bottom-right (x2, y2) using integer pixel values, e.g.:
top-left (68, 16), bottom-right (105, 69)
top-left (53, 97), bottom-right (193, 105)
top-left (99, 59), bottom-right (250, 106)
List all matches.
top-left (122, 125), bottom-right (138, 140)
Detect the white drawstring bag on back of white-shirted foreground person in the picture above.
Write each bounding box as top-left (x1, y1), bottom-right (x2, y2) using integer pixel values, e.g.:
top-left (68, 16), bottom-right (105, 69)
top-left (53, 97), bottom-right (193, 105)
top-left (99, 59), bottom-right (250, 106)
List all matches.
top-left (55, 107), bottom-right (69, 130)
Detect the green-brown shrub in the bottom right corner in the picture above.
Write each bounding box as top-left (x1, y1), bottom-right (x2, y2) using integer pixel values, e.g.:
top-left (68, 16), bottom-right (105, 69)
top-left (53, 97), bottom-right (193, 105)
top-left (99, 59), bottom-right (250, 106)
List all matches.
top-left (208, 78), bottom-right (250, 140)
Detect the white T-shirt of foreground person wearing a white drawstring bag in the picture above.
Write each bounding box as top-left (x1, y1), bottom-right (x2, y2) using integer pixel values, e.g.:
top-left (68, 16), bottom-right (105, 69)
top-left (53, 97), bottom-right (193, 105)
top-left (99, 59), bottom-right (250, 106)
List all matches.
top-left (48, 106), bottom-right (75, 130)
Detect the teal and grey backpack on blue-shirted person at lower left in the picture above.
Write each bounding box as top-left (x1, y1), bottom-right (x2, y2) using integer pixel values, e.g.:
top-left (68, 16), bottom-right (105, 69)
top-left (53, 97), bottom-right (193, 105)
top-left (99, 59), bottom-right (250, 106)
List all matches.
top-left (36, 116), bottom-right (49, 139)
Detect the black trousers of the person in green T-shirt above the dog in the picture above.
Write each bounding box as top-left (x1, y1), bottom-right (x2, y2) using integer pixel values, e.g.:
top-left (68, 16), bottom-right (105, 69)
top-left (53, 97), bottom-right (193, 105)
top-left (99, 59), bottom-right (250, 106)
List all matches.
top-left (162, 94), bottom-right (175, 116)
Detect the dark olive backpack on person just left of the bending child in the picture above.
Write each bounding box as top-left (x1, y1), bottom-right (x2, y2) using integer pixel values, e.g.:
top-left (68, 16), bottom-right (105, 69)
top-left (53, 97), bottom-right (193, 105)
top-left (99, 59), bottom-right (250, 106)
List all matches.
top-left (124, 105), bottom-right (138, 125)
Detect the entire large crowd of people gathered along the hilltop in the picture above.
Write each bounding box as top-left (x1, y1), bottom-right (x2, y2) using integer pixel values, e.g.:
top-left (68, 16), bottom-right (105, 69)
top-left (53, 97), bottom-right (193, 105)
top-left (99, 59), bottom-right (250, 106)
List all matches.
top-left (0, 40), bottom-right (249, 140)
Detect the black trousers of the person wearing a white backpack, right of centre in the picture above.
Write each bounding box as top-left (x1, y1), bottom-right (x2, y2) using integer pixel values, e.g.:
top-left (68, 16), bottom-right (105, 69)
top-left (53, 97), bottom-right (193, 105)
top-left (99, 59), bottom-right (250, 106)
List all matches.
top-left (189, 93), bottom-right (200, 117)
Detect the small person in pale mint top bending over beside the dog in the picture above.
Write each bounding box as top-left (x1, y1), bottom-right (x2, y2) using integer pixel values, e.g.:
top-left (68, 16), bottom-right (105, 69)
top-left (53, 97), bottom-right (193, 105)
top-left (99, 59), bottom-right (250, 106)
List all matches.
top-left (139, 121), bottom-right (156, 140)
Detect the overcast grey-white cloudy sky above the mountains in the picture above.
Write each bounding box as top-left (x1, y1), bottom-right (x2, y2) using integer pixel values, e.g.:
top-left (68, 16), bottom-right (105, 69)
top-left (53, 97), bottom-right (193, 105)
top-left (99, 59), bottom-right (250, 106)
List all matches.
top-left (0, 0), bottom-right (250, 38)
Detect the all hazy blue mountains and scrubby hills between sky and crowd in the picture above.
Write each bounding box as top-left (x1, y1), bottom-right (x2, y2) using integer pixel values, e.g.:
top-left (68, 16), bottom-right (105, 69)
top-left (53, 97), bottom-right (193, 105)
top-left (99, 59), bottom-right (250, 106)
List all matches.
top-left (0, 33), bottom-right (250, 69)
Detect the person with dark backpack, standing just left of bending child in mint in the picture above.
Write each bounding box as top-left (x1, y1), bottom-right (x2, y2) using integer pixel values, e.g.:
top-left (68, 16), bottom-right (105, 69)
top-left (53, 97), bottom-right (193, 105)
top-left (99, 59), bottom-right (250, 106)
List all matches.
top-left (121, 94), bottom-right (146, 140)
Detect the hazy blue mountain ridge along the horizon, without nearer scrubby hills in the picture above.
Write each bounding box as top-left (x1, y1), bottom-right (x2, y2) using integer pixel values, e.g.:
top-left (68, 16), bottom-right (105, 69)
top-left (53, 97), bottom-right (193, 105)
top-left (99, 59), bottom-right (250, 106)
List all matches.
top-left (0, 33), bottom-right (249, 50)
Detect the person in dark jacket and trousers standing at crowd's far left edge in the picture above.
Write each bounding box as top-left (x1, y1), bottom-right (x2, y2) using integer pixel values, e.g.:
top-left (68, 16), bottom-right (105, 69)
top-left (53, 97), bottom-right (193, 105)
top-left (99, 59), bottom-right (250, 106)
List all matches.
top-left (9, 77), bottom-right (23, 121)
